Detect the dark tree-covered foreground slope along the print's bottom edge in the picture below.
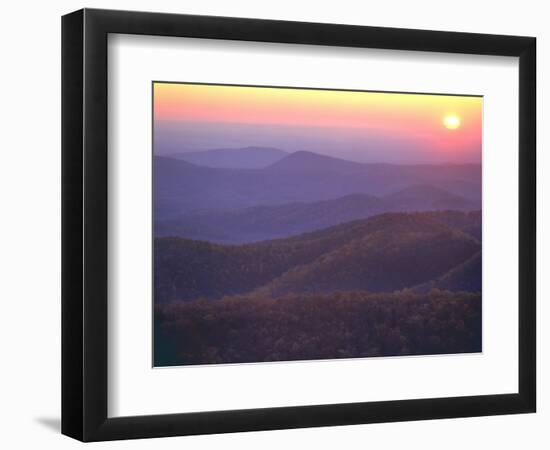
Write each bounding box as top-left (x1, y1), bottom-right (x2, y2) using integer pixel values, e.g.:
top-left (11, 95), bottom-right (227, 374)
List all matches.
top-left (154, 289), bottom-right (481, 366)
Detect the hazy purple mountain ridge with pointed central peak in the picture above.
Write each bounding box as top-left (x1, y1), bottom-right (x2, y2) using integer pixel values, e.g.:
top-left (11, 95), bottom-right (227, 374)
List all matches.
top-left (154, 149), bottom-right (481, 221)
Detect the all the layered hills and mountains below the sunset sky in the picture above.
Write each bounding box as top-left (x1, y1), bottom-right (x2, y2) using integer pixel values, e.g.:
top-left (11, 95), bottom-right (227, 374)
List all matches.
top-left (154, 148), bottom-right (481, 366)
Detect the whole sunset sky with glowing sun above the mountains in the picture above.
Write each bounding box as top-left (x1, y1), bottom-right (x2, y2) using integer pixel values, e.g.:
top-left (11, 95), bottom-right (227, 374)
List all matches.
top-left (153, 83), bottom-right (483, 164)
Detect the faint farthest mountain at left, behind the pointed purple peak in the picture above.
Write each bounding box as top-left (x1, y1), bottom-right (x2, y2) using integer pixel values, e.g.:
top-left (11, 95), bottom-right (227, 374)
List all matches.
top-left (170, 147), bottom-right (288, 169)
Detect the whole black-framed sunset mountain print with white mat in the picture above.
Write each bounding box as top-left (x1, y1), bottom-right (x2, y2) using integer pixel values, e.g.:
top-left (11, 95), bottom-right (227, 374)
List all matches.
top-left (62, 9), bottom-right (536, 441)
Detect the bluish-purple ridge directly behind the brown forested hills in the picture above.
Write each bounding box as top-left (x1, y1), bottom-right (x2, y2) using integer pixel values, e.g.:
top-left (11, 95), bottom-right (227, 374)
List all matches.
top-left (155, 185), bottom-right (478, 244)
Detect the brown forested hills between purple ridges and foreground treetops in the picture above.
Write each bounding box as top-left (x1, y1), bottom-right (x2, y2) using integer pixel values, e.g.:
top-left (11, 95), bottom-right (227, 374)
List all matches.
top-left (154, 212), bottom-right (481, 303)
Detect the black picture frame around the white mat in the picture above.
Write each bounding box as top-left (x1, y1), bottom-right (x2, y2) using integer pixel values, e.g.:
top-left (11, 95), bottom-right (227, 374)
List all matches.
top-left (62, 9), bottom-right (536, 441)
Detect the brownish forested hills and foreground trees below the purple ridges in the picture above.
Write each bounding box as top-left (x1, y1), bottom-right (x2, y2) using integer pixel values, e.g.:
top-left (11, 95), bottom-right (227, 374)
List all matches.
top-left (154, 212), bottom-right (481, 366)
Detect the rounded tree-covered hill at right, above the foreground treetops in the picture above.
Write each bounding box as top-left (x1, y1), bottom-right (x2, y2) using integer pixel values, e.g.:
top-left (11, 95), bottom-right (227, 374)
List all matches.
top-left (253, 214), bottom-right (479, 297)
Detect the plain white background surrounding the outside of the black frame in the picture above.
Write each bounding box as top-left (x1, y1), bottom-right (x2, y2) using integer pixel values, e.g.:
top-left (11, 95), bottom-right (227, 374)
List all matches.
top-left (0, 0), bottom-right (550, 450)
